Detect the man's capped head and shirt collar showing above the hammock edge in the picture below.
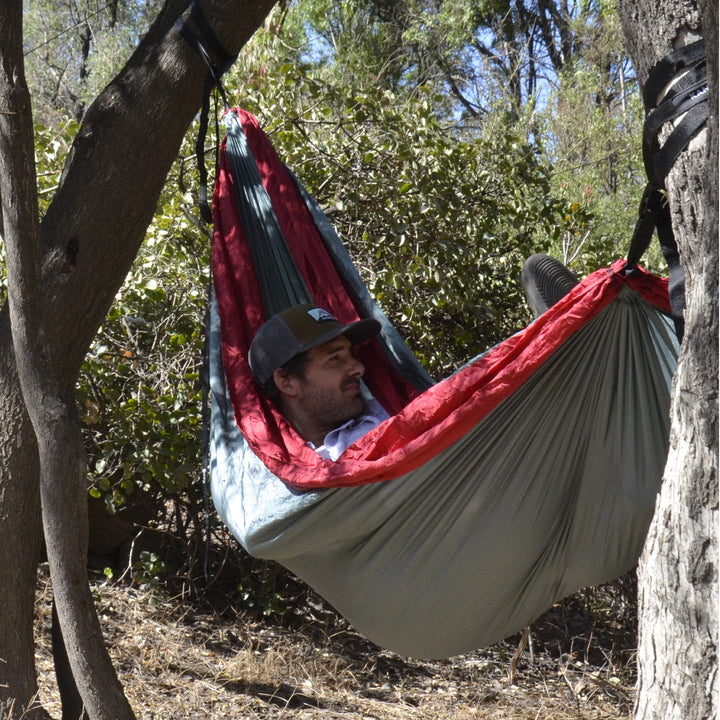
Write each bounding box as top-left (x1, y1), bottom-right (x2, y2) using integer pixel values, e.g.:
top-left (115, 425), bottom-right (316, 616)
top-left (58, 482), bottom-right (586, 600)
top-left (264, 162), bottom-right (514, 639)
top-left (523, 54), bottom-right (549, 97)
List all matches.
top-left (248, 304), bottom-right (389, 460)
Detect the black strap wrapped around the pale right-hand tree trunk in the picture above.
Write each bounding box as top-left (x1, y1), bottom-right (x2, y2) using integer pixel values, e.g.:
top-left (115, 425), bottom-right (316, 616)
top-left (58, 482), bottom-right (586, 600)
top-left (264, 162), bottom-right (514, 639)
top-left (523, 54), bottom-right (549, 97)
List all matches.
top-left (626, 40), bottom-right (708, 340)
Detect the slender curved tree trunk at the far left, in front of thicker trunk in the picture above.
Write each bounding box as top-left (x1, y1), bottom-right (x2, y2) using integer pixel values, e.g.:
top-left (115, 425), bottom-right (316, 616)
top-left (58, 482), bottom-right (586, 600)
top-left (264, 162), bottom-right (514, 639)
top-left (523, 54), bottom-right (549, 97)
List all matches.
top-left (0, 2), bottom-right (134, 718)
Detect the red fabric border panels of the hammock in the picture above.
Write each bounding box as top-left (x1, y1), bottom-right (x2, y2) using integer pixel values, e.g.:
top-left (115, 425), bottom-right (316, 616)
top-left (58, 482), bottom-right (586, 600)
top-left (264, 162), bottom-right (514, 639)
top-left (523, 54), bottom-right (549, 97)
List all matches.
top-left (212, 110), bottom-right (670, 490)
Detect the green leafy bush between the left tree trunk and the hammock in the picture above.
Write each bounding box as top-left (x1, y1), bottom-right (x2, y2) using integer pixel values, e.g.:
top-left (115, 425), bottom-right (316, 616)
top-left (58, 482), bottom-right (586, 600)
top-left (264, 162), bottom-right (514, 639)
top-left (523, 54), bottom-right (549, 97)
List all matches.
top-left (77, 145), bottom-right (210, 536)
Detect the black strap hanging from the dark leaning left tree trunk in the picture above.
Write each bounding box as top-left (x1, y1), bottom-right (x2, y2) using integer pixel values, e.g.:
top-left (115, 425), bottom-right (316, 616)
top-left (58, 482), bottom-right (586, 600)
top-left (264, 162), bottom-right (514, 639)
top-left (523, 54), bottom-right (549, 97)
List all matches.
top-left (175, 0), bottom-right (236, 223)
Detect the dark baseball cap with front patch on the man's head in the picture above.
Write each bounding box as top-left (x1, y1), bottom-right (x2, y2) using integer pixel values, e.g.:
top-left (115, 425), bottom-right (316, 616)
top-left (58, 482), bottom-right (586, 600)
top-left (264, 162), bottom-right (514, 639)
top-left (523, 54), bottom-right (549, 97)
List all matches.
top-left (248, 303), bottom-right (380, 386)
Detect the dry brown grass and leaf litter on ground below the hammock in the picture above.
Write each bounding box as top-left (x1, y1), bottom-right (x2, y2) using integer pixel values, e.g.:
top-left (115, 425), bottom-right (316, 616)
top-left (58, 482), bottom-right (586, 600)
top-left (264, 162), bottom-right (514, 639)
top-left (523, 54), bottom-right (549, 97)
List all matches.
top-left (36, 569), bottom-right (633, 720)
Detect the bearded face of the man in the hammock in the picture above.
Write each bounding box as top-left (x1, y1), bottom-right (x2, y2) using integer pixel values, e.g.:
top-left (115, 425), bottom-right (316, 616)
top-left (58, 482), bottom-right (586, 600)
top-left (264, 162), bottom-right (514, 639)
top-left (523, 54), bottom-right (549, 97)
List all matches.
top-left (297, 336), bottom-right (365, 432)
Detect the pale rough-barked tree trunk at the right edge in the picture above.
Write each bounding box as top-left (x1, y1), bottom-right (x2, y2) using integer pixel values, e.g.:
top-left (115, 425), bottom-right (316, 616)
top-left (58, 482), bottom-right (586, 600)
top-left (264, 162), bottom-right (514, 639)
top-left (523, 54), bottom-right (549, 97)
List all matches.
top-left (619, 0), bottom-right (720, 720)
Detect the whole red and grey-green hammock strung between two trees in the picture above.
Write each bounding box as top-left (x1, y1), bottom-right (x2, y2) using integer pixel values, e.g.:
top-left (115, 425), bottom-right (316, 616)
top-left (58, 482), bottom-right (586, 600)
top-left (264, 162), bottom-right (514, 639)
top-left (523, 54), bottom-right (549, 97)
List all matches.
top-left (210, 110), bottom-right (677, 657)
